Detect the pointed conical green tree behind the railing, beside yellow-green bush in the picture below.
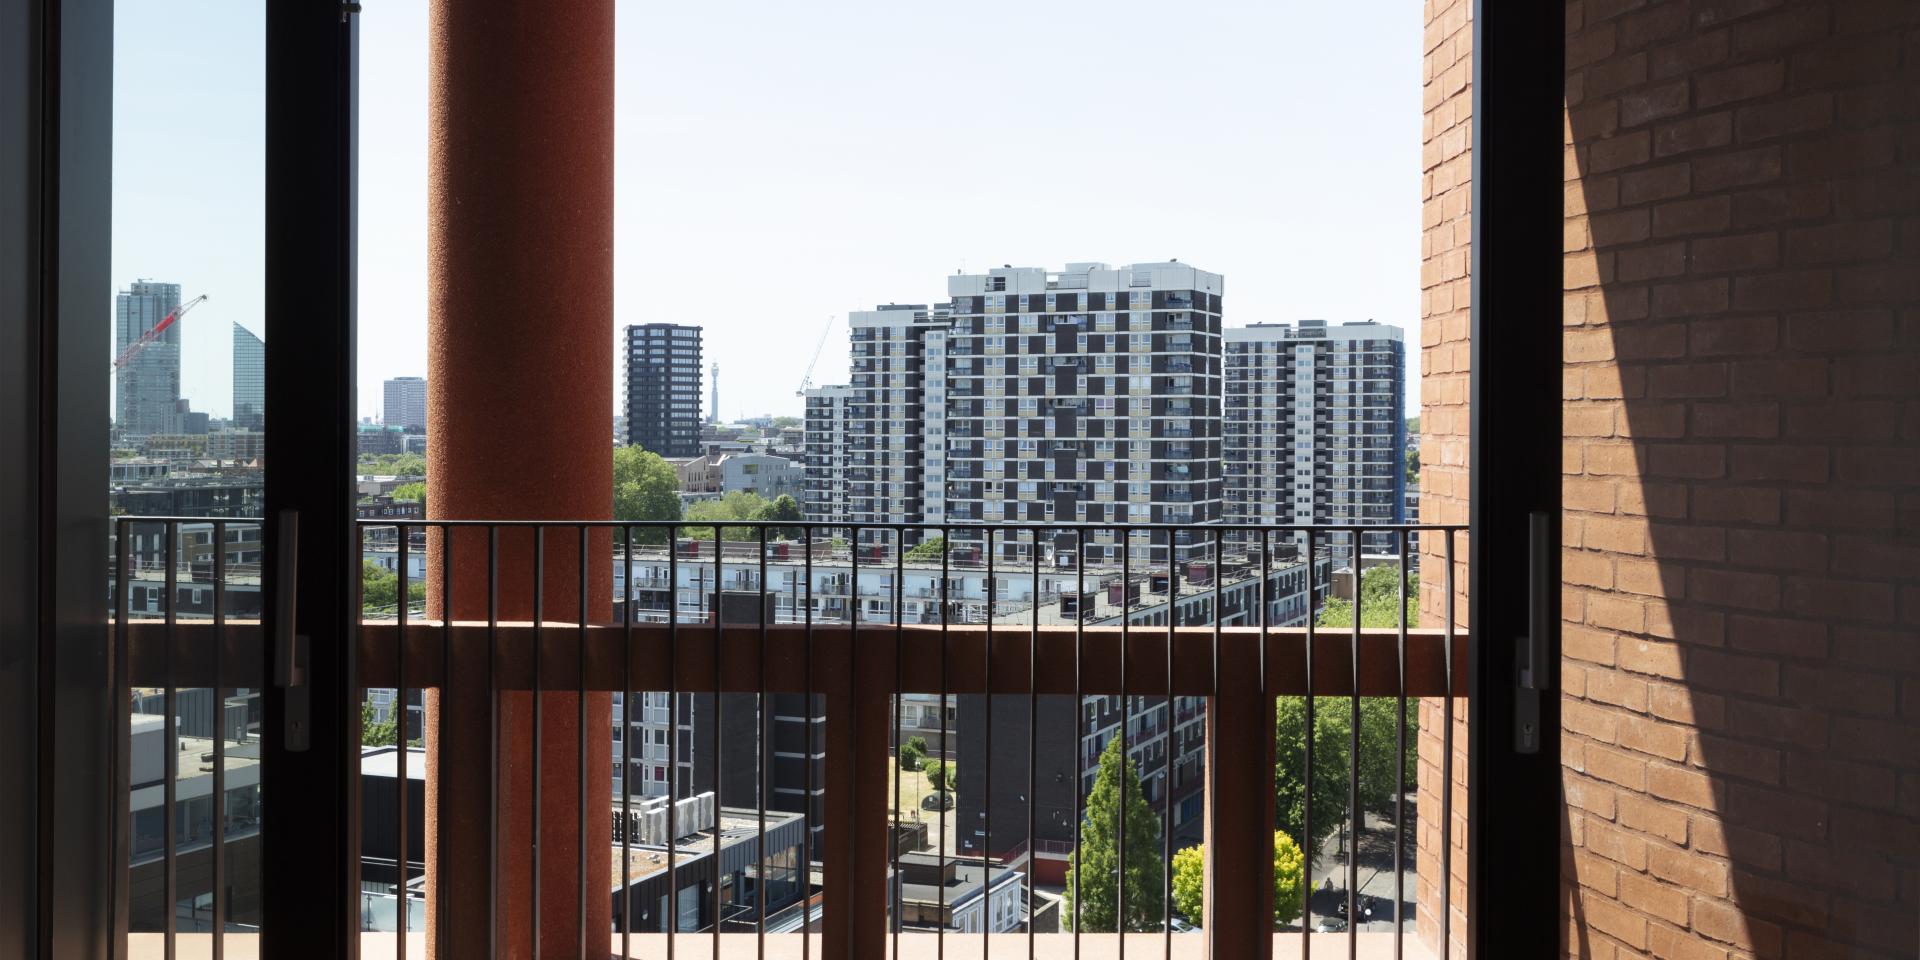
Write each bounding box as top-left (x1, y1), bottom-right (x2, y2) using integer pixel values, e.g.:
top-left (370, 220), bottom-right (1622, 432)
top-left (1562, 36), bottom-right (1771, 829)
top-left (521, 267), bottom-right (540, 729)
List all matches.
top-left (1068, 737), bottom-right (1167, 933)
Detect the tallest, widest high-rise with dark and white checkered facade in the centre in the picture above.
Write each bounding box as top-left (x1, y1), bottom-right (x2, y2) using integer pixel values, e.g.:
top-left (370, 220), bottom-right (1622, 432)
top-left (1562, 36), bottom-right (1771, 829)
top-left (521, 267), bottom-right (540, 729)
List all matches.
top-left (948, 261), bottom-right (1223, 564)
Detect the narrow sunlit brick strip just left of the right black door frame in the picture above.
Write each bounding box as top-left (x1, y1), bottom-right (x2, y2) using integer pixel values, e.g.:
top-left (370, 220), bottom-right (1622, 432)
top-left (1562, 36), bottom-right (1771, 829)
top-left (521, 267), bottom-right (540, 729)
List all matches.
top-left (1415, 0), bottom-right (1473, 952)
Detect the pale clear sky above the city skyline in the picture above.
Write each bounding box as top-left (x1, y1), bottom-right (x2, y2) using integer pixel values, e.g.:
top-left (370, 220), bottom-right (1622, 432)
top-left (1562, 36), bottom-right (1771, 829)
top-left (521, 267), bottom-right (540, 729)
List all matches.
top-left (104, 0), bottom-right (1421, 419)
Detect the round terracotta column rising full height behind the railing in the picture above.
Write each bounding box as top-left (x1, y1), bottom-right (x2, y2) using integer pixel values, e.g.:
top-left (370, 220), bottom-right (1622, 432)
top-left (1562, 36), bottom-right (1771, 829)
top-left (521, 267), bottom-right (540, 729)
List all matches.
top-left (426, 0), bottom-right (614, 958)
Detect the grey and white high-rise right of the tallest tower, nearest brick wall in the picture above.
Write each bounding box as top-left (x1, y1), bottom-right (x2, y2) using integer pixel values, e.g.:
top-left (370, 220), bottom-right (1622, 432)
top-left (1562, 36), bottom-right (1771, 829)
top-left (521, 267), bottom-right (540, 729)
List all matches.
top-left (1225, 321), bottom-right (1407, 566)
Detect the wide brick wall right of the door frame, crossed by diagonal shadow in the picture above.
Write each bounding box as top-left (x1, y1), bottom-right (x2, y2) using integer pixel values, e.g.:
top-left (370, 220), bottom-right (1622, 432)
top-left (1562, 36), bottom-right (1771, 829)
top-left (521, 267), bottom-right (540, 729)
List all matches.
top-left (1566, 0), bottom-right (1920, 960)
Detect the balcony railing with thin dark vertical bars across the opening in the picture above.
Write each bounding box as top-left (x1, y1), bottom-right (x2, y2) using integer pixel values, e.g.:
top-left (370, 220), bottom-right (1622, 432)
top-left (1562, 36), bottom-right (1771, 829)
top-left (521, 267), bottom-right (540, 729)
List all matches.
top-left (113, 518), bottom-right (1467, 958)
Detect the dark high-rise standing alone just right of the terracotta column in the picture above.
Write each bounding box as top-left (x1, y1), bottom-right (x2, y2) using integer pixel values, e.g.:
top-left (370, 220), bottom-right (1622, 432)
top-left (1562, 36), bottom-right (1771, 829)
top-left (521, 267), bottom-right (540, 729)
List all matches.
top-left (626, 323), bottom-right (701, 457)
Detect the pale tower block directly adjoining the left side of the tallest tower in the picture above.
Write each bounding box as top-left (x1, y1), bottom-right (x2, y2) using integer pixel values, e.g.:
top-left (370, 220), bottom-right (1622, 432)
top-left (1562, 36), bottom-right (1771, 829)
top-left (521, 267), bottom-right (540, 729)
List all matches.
top-left (847, 303), bottom-right (948, 543)
